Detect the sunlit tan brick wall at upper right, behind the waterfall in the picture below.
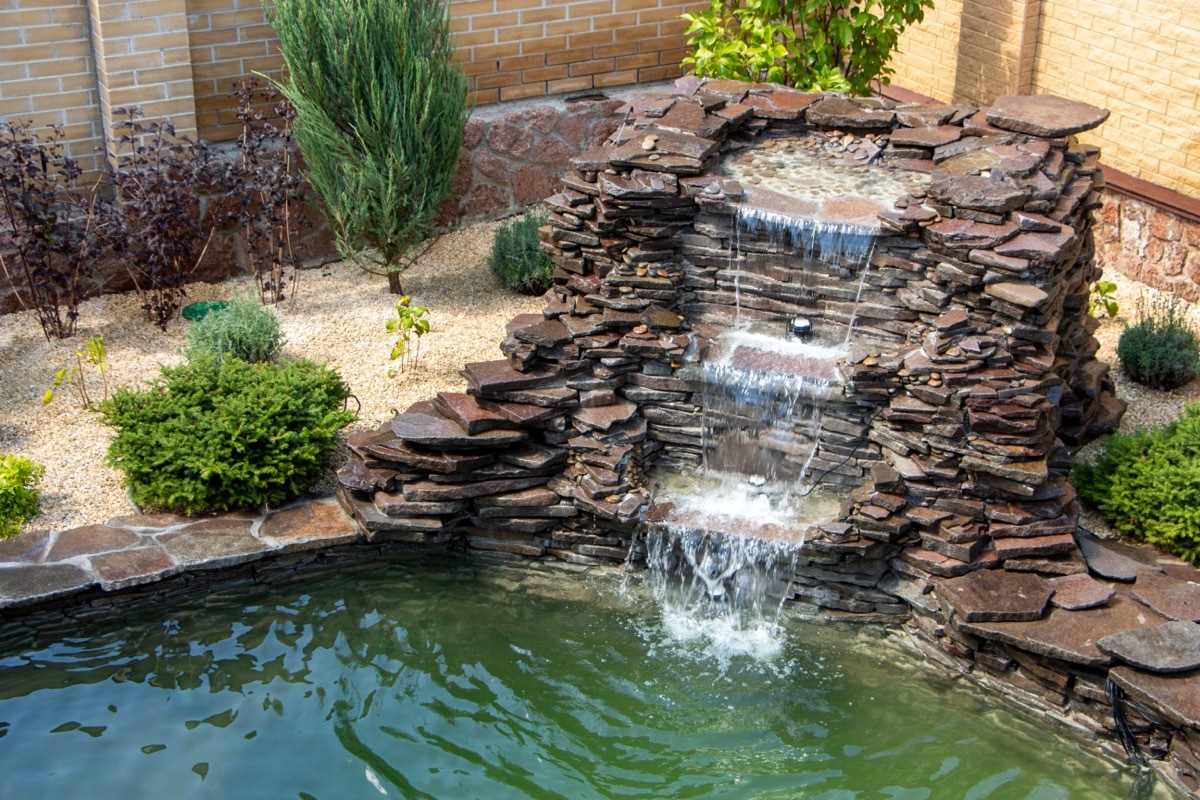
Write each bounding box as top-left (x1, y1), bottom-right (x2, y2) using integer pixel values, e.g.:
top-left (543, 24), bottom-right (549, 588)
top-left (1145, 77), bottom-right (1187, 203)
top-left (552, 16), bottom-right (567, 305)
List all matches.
top-left (893, 0), bottom-right (1200, 198)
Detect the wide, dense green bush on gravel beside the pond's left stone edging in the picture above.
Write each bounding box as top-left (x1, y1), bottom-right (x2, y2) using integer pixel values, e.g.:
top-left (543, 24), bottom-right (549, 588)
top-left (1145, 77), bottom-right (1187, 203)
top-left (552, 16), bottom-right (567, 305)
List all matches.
top-left (101, 359), bottom-right (354, 515)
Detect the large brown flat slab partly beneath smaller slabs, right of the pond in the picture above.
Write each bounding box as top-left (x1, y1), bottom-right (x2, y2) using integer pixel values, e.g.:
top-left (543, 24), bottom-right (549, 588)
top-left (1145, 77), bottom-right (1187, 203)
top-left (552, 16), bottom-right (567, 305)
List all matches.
top-left (959, 595), bottom-right (1166, 667)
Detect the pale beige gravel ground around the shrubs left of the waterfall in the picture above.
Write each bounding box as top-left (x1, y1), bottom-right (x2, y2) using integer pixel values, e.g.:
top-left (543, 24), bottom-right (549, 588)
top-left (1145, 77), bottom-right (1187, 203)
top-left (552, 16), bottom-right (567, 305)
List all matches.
top-left (0, 223), bottom-right (542, 528)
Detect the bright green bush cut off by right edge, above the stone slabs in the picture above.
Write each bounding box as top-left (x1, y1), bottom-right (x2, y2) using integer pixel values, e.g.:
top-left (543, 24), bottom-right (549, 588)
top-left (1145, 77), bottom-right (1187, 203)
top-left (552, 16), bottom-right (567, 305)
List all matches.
top-left (1074, 404), bottom-right (1200, 564)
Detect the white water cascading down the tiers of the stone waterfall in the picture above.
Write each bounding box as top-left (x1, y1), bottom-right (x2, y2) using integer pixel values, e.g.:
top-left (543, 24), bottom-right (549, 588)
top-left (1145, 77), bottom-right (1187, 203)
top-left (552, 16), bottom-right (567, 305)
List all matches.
top-left (646, 207), bottom-right (877, 655)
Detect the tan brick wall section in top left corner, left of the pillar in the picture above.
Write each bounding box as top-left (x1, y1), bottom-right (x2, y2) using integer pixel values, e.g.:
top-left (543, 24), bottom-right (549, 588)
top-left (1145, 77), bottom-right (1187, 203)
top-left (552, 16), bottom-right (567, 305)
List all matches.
top-left (0, 0), bottom-right (103, 172)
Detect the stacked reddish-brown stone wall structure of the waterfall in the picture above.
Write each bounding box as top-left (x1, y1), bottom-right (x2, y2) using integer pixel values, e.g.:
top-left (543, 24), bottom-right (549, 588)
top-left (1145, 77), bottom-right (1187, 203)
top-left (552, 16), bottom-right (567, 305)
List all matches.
top-left (342, 79), bottom-right (1121, 615)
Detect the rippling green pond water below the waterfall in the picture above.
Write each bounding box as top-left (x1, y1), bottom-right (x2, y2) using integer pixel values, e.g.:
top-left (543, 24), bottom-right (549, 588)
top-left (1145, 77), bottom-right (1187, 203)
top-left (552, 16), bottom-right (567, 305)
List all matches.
top-left (0, 557), bottom-right (1157, 800)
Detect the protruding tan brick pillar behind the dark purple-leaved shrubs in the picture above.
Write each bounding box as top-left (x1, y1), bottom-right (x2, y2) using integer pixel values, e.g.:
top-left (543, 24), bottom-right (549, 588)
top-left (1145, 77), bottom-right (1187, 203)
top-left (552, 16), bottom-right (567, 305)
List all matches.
top-left (88, 0), bottom-right (197, 163)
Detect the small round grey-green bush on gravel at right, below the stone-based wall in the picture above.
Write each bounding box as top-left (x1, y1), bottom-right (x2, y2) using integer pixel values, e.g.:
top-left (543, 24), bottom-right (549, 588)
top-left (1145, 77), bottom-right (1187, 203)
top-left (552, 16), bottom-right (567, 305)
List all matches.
top-left (1117, 297), bottom-right (1200, 389)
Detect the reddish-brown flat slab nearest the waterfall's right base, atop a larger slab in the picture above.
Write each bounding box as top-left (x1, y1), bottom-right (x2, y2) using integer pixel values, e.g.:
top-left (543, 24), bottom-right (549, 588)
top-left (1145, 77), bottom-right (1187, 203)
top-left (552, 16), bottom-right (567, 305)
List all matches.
top-left (937, 570), bottom-right (1054, 622)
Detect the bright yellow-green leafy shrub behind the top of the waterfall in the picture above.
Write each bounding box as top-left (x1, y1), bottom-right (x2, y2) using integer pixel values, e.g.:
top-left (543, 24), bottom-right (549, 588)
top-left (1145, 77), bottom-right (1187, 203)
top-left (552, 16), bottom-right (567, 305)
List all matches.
top-left (683, 0), bottom-right (934, 95)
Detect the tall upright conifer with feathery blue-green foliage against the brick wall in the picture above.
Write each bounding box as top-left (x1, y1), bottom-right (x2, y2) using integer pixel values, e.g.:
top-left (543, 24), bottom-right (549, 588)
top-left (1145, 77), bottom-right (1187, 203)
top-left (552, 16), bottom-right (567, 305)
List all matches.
top-left (270, 0), bottom-right (467, 293)
